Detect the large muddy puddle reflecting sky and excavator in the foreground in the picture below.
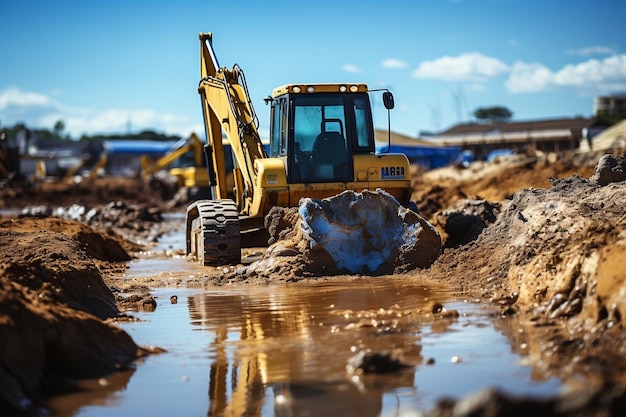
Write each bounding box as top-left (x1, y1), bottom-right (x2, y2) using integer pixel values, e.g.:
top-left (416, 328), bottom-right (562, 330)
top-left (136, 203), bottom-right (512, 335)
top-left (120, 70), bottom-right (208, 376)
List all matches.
top-left (47, 272), bottom-right (560, 417)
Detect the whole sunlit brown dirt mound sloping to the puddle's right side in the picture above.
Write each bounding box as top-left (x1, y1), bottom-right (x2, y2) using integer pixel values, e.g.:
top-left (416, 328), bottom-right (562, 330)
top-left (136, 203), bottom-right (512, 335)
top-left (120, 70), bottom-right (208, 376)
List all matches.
top-left (416, 157), bottom-right (626, 382)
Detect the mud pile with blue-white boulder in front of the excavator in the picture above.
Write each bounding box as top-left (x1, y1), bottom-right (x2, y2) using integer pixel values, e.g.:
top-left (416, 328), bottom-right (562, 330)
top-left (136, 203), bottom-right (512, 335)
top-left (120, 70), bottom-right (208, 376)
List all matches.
top-left (238, 190), bottom-right (441, 277)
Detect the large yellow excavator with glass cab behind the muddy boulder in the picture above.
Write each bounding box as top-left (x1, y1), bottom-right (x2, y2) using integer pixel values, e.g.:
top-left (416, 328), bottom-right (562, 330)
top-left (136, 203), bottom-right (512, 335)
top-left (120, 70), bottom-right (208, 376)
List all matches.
top-left (186, 33), bottom-right (411, 265)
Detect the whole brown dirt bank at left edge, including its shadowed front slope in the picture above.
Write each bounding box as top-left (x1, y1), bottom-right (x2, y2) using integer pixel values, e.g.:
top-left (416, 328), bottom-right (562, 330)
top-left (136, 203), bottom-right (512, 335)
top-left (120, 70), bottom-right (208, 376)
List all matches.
top-left (0, 224), bottom-right (143, 409)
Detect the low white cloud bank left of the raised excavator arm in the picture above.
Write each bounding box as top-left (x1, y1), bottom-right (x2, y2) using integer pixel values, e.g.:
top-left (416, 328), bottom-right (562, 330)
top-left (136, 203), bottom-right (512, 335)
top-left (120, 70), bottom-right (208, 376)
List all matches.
top-left (0, 87), bottom-right (195, 139)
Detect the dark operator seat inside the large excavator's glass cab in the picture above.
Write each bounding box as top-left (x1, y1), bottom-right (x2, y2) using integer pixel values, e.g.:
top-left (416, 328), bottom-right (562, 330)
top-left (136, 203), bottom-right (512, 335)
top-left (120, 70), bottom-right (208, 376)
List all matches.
top-left (313, 132), bottom-right (353, 181)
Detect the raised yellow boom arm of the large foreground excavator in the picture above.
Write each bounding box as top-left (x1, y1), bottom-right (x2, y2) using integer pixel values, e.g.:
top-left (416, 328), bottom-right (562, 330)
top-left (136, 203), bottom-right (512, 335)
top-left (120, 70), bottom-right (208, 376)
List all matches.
top-left (198, 33), bottom-right (267, 215)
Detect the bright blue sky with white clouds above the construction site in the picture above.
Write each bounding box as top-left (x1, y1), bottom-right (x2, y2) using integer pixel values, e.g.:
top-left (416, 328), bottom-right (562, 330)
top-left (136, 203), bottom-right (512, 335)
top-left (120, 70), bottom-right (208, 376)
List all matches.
top-left (0, 0), bottom-right (626, 138)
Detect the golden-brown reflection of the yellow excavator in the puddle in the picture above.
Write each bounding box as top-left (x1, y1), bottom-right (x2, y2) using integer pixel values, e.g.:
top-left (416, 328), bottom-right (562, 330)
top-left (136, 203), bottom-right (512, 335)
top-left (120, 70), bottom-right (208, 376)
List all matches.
top-left (187, 288), bottom-right (422, 417)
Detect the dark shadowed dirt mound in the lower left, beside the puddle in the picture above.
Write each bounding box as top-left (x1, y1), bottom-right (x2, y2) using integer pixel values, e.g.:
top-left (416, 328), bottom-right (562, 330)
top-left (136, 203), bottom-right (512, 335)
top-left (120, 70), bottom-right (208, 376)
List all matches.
top-left (0, 279), bottom-right (141, 415)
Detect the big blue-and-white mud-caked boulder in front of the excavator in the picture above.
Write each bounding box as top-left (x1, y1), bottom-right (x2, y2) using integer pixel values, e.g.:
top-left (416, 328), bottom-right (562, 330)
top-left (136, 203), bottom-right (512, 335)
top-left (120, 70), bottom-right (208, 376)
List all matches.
top-left (298, 190), bottom-right (441, 274)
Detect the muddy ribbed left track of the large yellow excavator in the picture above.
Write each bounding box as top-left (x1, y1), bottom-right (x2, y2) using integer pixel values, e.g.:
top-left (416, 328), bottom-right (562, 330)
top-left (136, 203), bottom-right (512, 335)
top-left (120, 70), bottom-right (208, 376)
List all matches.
top-left (186, 199), bottom-right (241, 266)
